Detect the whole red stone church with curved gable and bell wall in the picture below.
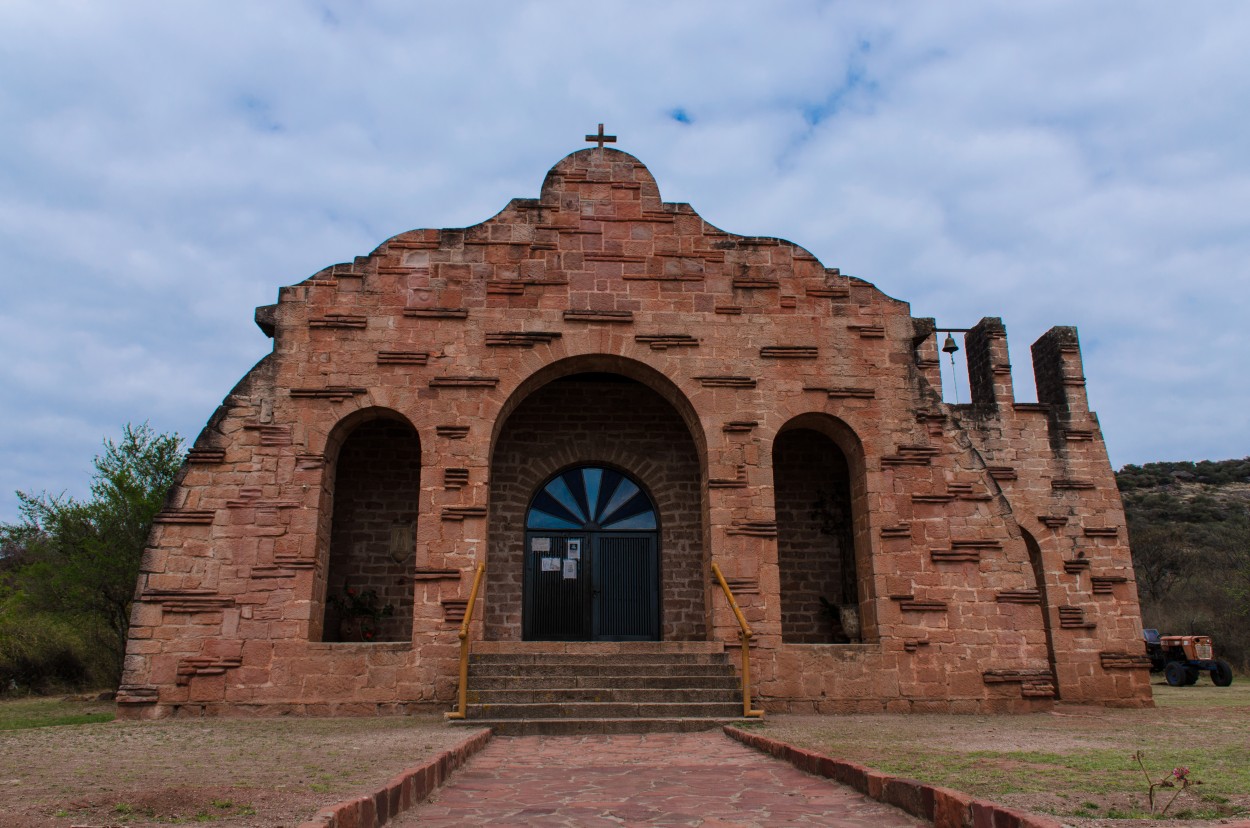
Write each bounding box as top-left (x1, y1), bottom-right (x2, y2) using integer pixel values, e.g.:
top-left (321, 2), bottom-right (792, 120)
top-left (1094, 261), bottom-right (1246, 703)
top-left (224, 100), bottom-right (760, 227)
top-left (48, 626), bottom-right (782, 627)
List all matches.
top-left (118, 135), bottom-right (1150, 717)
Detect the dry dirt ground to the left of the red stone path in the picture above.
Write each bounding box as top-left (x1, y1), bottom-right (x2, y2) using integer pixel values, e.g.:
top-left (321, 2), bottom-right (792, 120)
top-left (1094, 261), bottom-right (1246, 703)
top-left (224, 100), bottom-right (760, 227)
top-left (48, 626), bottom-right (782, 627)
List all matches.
top-left (0, 715), bottom-right (469, 828)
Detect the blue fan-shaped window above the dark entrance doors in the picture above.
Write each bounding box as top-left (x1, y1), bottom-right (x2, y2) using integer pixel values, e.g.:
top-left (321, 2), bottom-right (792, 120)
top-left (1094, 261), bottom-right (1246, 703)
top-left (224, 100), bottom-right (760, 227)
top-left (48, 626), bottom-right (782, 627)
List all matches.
top-left (525, 467), bottom-right (655, 532)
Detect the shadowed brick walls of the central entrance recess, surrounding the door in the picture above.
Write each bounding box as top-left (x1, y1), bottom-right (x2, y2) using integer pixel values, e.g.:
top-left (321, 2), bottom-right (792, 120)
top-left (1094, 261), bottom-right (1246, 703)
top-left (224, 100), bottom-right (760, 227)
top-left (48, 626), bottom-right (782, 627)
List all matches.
top-left (483, 372), bottom-right (706, 640)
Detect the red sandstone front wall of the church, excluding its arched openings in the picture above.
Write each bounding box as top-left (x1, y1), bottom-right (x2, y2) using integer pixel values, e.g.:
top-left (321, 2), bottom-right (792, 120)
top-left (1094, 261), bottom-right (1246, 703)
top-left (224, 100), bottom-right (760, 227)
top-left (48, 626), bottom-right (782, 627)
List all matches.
top-left (119, 149), bottom-right (1149, 715)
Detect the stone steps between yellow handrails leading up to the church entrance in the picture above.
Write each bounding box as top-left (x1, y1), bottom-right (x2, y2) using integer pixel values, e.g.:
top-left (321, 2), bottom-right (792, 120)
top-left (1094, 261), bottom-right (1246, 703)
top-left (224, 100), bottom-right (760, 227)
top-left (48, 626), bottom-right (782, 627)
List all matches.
top-left (455, 642), bottom-right (743, 735)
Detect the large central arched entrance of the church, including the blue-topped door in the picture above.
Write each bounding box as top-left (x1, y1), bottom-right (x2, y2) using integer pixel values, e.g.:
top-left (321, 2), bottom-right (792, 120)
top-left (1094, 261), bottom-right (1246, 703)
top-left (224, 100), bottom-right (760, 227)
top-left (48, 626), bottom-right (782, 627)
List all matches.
top-left (483, 367), bottom-right (708, 642)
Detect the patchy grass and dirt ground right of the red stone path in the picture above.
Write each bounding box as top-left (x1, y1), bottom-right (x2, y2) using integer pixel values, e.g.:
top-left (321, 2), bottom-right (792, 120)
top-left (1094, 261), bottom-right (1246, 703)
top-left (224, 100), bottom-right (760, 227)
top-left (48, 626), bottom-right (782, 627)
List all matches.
top-left (764, 679), bottom-right (1250, 819)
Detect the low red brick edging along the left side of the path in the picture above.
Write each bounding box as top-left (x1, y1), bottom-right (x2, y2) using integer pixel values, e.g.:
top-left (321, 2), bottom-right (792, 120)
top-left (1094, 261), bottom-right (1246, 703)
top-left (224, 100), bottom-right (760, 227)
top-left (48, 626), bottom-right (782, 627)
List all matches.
top-left (299, 729), bottom-right (490, 828)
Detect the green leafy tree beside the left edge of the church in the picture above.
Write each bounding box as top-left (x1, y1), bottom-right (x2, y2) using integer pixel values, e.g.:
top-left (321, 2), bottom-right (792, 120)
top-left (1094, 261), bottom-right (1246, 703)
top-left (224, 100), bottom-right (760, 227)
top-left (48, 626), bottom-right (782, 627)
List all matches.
top-left (0, 423), bottom-right (183, 683)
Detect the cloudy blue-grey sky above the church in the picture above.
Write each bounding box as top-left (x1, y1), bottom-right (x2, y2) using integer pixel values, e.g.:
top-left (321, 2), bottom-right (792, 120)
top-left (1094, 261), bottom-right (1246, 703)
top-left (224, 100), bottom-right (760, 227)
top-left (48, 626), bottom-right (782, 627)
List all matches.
top-left (0, 0), bottom-right (1250, 520)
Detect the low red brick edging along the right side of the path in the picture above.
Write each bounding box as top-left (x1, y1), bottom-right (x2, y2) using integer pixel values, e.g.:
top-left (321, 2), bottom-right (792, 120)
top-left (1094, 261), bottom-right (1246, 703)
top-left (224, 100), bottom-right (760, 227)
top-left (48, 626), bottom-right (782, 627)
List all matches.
top-left (725, 724), bottom-right (1061, 828)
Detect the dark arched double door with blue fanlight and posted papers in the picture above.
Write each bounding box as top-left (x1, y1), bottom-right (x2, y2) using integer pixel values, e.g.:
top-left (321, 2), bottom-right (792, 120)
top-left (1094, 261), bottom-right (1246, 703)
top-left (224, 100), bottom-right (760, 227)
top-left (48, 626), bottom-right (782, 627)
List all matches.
top-left (523, 465), bottom-right (660, 642)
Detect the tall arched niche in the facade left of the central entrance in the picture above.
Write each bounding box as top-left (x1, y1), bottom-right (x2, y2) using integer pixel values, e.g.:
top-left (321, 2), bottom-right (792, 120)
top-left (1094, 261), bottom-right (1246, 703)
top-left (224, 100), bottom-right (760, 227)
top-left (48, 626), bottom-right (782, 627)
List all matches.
top-left (321, 408), bottom-right (421, 642)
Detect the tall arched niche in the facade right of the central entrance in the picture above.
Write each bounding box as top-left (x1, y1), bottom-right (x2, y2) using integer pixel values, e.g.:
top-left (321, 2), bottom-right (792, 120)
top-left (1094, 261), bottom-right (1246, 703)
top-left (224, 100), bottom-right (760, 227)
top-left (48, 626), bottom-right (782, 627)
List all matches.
top-left (773, 414), bottom-right (869, 644)
